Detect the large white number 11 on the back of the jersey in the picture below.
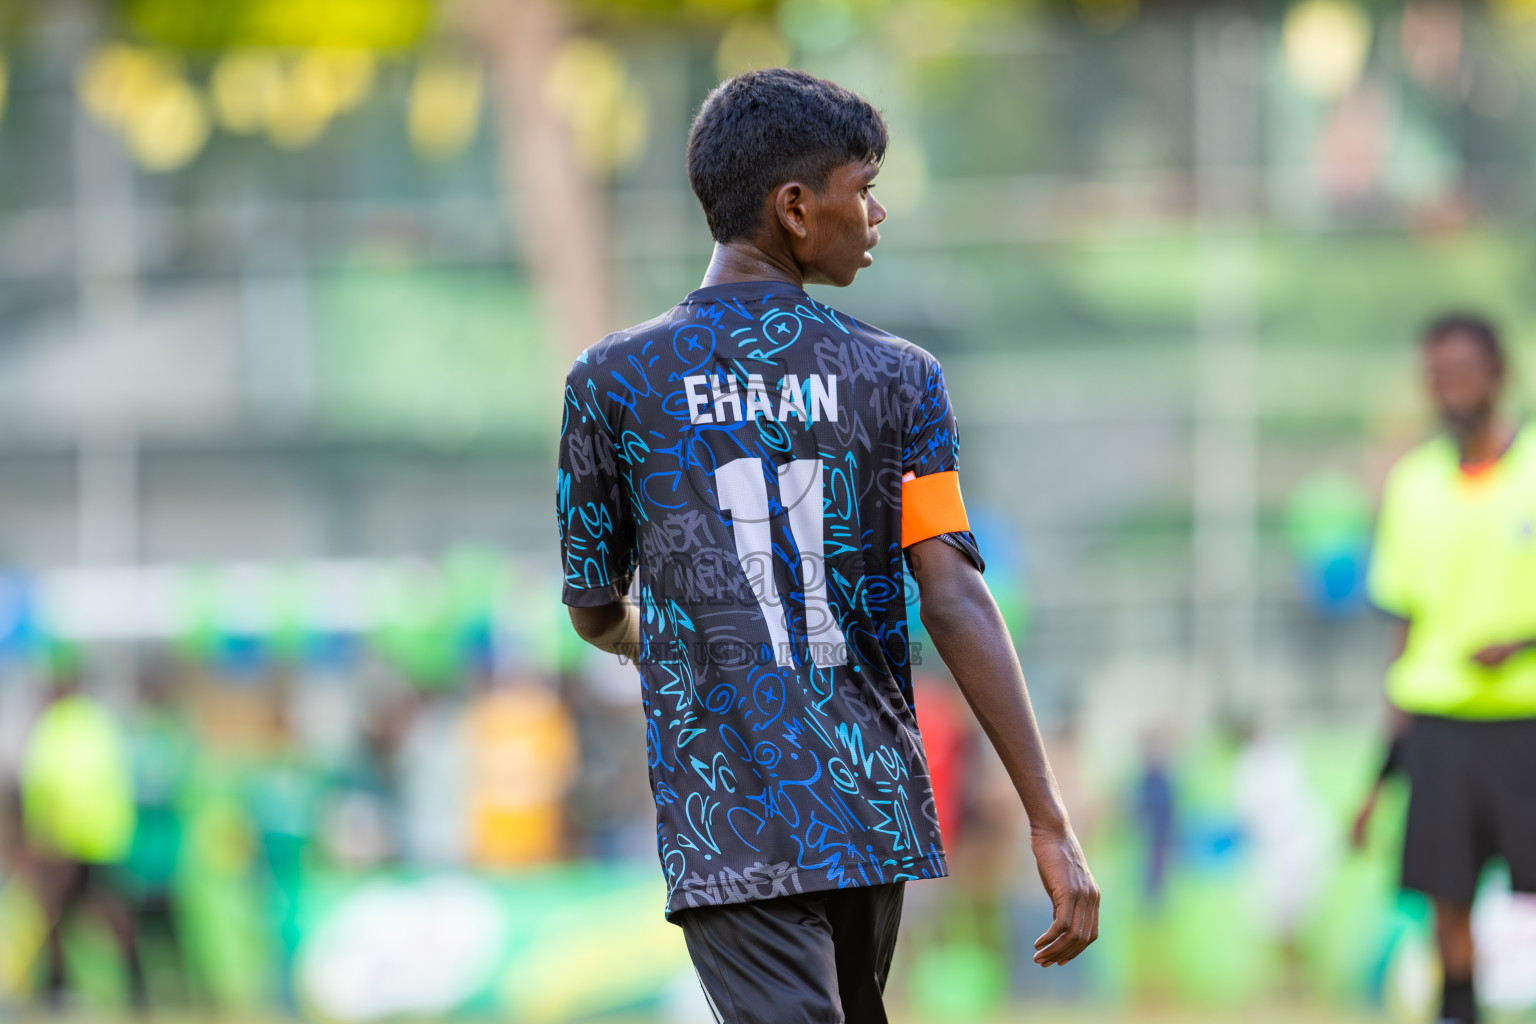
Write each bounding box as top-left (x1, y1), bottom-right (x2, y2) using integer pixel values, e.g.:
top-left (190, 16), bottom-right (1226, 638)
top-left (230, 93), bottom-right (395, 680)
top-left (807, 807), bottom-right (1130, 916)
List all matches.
top-left (714, 459), bottom-right (848, 668)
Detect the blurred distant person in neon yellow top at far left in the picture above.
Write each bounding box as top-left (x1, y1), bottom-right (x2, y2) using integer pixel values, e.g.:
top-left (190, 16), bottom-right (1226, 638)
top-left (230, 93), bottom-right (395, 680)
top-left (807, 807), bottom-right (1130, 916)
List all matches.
top-left (22, 652), bottom-right (146, 1007)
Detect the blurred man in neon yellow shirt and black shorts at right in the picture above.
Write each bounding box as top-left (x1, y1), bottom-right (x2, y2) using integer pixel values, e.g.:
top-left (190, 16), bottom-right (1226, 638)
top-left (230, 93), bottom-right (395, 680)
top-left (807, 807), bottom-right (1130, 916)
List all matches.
top-left (1361, 316), bottom-right (1536, 1022)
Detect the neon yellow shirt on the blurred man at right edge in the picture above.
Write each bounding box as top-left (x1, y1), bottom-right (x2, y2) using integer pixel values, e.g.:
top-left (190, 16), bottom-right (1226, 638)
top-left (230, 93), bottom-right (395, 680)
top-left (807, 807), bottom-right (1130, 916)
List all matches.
top-left (1370, 428), bottom-right (1536, 718)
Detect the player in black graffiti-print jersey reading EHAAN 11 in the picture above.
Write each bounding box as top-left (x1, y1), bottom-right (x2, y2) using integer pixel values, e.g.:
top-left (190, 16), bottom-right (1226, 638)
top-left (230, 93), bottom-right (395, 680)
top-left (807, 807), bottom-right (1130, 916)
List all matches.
top-left (558, 69), bottom-right (1098, 1024)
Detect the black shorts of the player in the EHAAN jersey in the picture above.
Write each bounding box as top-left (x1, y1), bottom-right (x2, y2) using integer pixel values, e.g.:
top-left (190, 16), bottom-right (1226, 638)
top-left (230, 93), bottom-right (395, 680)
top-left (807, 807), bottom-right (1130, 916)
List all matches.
top-left (673, 883), bottom-right (905, 1024)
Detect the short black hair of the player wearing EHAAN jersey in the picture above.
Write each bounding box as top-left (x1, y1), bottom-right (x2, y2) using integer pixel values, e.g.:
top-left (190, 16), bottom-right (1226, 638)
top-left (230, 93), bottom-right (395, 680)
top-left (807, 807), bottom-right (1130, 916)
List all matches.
top-left (688, 68), bottom-right (889, 243)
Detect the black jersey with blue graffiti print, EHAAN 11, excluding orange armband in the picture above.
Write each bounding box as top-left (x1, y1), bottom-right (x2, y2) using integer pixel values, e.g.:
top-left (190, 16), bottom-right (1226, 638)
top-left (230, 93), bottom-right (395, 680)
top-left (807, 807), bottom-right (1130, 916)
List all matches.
top-left (556, 282), bottom-right (978, 913)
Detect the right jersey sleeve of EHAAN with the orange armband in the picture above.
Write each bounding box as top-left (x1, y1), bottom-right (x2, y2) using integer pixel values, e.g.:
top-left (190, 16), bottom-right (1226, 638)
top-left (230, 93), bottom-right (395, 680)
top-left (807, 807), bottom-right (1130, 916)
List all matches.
top-left (902, 358), bottom-right (985, 570)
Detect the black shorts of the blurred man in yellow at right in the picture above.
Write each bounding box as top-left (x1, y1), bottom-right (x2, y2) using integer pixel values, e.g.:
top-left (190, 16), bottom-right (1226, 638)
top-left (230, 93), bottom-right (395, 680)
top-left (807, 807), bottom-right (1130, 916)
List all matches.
top-left (1402, 715), bottom-right (1536, 904)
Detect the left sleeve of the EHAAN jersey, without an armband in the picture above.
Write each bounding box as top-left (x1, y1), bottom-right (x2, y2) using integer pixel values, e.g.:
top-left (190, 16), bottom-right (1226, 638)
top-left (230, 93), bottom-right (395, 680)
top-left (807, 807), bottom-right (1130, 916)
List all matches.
top-left (554, 362), bottom-right (634, 608)
